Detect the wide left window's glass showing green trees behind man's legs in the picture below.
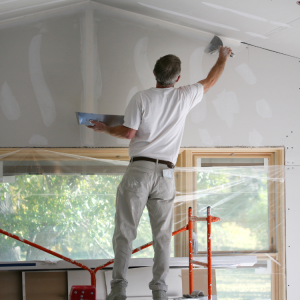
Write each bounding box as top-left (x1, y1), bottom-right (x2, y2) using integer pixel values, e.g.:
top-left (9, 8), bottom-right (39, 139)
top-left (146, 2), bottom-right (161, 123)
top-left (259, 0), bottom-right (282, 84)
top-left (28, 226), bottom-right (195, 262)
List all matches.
top-left (0, 174), bottom-right (153, 261)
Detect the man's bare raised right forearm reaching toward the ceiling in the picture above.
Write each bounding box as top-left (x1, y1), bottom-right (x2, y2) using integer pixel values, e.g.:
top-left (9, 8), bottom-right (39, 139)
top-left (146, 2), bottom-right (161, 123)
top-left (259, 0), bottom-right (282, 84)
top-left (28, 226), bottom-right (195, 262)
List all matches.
top-left (198, 47), bottom-right (232, 93)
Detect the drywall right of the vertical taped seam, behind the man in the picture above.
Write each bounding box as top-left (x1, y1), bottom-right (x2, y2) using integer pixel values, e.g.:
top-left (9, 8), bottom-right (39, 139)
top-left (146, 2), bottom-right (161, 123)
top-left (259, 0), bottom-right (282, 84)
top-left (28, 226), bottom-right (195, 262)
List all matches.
top-left (94, 4), bottom-right (300, 159)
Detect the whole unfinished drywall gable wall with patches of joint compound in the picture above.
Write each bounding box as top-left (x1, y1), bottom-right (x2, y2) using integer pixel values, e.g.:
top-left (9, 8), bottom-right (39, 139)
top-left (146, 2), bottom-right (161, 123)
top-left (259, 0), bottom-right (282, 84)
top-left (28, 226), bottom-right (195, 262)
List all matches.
top-left (0, 3), bottom-right (300, 299)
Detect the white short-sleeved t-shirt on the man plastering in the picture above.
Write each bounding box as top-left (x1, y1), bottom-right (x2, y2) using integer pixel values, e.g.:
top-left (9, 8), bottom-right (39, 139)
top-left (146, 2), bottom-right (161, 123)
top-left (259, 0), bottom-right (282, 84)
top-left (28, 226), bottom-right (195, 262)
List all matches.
top-left (123, 83), bottom-right (203, 164)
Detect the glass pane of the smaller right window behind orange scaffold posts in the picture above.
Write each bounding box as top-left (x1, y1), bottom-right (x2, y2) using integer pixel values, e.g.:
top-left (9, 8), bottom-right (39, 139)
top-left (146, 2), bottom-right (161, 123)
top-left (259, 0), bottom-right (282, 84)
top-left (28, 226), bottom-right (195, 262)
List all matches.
top-left (197, 159), bottom-right (269, 251)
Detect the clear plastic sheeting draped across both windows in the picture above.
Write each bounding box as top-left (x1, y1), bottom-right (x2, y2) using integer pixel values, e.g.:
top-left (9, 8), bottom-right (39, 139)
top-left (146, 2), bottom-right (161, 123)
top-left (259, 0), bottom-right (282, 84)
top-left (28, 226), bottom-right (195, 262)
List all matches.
top-left (0, 148), bottom-right (286, 299)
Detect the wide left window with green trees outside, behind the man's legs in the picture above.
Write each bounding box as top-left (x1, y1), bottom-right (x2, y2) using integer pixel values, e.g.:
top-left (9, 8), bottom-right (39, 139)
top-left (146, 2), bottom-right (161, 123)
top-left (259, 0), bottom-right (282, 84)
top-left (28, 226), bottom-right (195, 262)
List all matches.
top-left (0, 149), bottom-right (153, 261)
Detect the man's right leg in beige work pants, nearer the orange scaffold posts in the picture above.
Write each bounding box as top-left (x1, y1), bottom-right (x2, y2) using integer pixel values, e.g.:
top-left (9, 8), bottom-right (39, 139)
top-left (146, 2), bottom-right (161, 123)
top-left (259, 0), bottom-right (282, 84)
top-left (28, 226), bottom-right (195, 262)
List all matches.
top-left (147, 172), bottom-right (175, 292)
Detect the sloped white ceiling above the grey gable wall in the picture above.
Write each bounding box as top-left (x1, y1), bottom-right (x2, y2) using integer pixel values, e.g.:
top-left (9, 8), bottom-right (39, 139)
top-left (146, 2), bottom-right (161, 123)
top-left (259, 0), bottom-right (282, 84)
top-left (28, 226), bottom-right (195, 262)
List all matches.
top-left (0, 0), bottom-right (300, 57)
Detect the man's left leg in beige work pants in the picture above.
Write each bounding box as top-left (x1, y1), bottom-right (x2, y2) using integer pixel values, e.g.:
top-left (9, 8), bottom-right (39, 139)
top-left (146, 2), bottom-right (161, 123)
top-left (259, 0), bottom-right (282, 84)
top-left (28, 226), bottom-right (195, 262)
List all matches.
top-left (111, 167), bottom-right (152, 288)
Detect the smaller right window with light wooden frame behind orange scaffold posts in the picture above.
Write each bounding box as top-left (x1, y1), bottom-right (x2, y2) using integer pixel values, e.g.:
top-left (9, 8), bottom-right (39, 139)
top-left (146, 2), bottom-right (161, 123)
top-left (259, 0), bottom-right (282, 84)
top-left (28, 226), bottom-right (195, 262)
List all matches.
top-left (175, 148), bottom-right (286, 299)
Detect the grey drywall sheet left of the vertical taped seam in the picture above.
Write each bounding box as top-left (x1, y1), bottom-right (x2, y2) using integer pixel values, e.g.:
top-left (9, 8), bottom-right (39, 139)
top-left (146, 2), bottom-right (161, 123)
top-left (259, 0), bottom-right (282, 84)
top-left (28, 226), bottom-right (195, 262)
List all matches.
top-left (0, 5), bottom-right (85, 147)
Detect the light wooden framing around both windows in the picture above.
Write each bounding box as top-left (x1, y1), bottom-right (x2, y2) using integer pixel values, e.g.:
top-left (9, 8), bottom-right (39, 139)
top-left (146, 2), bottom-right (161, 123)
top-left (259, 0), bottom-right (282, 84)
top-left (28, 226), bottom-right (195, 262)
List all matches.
top-left (0, 147), bottom-right (286, 300)
